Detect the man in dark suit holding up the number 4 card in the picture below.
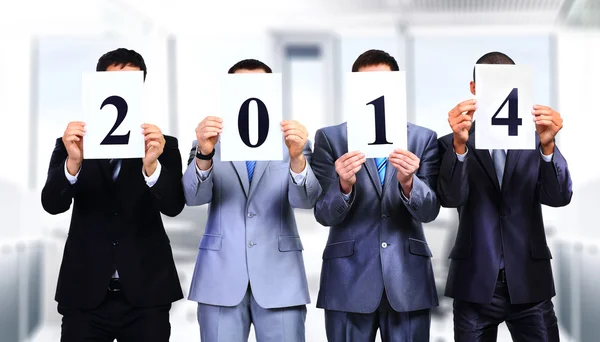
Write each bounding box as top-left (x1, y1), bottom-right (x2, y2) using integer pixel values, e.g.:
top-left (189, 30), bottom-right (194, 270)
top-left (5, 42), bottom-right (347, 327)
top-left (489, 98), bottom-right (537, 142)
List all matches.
top-left (438, 52), bottom-right (572, 342)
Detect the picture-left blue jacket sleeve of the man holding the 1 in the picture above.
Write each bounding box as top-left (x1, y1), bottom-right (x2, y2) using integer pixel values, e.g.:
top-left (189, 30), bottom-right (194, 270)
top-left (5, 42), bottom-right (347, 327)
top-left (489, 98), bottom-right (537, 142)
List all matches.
top-left (312, 130), bottom-right (356, 227)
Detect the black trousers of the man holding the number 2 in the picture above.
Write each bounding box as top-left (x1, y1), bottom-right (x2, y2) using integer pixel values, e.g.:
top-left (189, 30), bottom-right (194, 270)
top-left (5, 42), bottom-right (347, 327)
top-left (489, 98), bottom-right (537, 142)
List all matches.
top-left (58, 292), bottom-right (171, 342)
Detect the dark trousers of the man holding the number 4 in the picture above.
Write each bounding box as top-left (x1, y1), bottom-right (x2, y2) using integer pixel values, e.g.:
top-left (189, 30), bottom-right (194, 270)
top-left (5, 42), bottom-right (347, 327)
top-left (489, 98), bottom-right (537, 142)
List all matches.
top-left (454, 277), bottom-right (559, 342)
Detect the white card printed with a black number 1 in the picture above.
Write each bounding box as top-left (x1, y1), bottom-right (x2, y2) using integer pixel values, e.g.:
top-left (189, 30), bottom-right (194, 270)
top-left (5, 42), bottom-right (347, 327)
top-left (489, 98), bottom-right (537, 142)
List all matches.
top-left (345, 71), bottom-right (407, 158)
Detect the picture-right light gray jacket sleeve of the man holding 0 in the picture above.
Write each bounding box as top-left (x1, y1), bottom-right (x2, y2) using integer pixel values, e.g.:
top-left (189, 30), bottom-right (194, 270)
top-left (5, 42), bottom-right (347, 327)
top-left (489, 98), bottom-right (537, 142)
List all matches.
top-left (288, 141), bottom-right (321, 209)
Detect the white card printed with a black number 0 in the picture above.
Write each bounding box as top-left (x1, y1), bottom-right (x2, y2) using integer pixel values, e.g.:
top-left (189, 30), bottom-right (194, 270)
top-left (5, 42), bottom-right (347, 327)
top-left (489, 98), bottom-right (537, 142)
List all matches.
top-left (220, 73), bottom-right (283, 161)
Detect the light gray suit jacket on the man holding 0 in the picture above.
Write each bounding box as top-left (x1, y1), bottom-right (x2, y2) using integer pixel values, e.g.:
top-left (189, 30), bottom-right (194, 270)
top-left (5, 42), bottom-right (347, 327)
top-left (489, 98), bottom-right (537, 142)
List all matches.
top-left (183, 142), bottom-right (321, 308)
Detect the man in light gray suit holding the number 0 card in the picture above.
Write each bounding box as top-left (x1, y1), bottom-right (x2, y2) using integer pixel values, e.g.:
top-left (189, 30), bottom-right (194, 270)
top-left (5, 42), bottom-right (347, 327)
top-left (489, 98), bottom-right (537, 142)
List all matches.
top-left (183, 60), bottom-right (321, 342)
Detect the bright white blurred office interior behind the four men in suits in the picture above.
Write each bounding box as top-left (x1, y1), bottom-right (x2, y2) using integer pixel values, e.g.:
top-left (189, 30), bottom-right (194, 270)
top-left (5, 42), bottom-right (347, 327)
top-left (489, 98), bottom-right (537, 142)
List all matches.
top-left (0, 0), bottom-right (600, 342)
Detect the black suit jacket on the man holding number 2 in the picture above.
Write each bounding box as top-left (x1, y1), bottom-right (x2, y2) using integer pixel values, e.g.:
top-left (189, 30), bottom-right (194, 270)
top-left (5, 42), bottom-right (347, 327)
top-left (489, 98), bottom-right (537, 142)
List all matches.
top-left (42, 136), bottom-right (185, 308)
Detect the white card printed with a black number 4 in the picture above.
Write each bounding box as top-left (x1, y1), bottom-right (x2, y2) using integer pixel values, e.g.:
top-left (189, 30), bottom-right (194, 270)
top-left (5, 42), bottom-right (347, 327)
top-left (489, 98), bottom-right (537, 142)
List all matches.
top-left (474, 64), bottom-right (536, 150)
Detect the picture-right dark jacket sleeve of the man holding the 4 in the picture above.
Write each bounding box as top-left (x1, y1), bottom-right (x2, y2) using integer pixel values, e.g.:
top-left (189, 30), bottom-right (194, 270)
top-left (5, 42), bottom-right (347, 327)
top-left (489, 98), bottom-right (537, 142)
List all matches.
top-left (539, 146), bottom-right (573, 207)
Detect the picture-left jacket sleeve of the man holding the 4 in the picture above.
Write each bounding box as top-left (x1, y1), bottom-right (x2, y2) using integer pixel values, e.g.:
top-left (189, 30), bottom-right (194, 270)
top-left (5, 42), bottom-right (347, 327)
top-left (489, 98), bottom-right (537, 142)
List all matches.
top-left (437, 138), bottom-right (473, 208)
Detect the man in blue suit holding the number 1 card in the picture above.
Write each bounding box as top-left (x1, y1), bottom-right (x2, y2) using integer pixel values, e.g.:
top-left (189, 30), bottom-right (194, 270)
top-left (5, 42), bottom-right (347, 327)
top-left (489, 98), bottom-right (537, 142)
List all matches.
top-left (312, 50), bottom-right (440, 342)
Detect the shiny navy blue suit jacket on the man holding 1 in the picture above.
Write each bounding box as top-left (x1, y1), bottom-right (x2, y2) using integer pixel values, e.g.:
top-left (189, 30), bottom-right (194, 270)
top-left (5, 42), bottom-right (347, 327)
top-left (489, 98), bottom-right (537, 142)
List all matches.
top-left (312, 123), bottom-right (440, 313)
